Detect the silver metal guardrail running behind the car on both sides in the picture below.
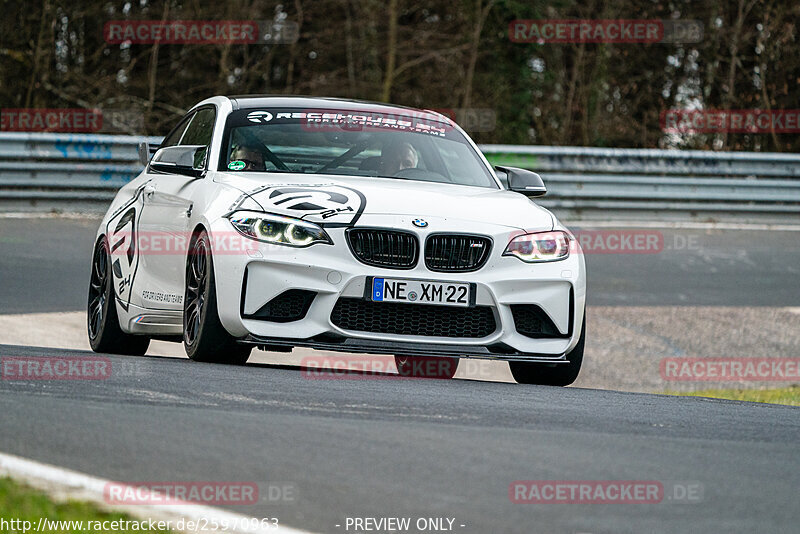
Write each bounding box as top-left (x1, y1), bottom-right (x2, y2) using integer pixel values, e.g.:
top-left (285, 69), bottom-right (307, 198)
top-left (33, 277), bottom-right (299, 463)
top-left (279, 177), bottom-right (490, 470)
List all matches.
top-left (0, 133), bottom-right (800, 222)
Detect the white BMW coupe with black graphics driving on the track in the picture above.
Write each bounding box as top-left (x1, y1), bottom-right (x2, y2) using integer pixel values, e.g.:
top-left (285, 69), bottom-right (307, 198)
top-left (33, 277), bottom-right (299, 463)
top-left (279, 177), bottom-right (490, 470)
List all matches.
top-left (88, 96), bottom-right (586, 386)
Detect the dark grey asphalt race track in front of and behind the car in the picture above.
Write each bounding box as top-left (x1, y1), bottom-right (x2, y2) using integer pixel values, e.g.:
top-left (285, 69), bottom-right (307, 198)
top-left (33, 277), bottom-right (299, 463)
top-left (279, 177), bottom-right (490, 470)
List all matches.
top-left (0, 219), bottom-right (800, 533)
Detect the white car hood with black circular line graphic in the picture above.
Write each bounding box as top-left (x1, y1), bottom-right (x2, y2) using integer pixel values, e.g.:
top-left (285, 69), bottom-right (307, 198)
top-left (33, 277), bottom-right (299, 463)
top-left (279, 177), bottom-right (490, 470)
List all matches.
top-left (214, 172), bottom-right (553, 230)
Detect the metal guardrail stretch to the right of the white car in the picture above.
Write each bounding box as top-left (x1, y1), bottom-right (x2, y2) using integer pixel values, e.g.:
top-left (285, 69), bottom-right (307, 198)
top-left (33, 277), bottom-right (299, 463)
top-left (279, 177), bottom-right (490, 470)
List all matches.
top-left (481, 145), bottom-right (800, 223)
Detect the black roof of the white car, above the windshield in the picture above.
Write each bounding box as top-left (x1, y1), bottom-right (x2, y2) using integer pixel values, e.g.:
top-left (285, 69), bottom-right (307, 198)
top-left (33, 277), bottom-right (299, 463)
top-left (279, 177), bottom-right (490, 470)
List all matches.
top-left (228, 95), bottom-right (452, 122)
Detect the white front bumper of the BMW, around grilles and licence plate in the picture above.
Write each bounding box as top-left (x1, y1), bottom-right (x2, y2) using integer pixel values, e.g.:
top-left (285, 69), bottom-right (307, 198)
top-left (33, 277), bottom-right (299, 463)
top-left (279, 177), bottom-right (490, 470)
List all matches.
top-left (212, 216), bottom-right (586, 363)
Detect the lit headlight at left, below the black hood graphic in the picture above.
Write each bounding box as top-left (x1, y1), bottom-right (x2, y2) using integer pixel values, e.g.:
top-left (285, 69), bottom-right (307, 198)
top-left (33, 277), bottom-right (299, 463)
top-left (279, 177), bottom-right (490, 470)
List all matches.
top-left (228, 211), bottom-right (333, 247)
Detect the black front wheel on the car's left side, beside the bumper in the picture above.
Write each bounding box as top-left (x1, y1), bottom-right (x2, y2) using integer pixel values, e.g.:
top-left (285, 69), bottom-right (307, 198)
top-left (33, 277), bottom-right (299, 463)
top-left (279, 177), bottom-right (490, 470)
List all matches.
top-left (183, 230), bottom-right (251, 365)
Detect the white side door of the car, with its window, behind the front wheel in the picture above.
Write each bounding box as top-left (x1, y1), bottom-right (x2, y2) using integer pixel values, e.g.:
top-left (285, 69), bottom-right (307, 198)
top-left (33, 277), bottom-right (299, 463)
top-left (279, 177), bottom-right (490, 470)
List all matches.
top-left (136, 106), bottom-right (216, 310)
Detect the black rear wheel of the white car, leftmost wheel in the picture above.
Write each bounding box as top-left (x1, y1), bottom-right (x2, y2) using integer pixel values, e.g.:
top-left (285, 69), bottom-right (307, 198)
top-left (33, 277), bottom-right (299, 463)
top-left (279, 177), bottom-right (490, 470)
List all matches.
top-left (86, 236), bottom-right (150, 356)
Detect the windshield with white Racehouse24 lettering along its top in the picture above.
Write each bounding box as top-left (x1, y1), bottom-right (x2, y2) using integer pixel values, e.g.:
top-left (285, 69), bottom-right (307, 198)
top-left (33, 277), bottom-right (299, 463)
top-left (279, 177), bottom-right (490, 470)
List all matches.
top-left (220, 109), bottom-right (498, 189)
